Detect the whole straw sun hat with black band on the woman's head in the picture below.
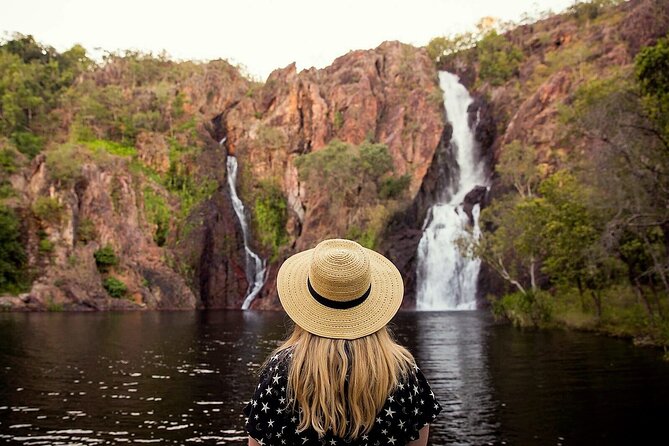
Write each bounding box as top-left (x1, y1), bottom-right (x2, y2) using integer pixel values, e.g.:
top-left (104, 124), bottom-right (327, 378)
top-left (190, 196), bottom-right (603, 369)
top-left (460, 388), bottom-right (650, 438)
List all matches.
top-left (277, 239), bottom-right (404, 339)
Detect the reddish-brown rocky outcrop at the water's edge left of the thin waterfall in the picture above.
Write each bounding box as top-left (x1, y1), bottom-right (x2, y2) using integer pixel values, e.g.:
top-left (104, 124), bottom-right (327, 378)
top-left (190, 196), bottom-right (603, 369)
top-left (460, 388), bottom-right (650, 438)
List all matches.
top-left (0, 152), bottom-right (197, 310)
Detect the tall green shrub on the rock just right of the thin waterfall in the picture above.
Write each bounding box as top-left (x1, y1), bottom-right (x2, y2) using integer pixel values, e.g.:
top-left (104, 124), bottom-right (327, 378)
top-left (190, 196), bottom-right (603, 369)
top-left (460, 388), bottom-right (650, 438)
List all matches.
top-left (253, 180), bottom-right (288, 260)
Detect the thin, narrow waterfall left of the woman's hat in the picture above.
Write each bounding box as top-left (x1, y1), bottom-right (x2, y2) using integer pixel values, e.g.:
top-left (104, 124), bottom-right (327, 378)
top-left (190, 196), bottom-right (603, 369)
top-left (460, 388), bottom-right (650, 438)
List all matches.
top-left (220, 138), bottom-right (267, 310)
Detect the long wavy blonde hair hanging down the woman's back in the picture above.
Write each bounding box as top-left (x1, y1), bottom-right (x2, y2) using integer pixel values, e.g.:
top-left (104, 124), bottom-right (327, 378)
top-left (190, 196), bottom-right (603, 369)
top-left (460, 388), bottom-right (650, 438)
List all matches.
top-left (265, 325), bottom-right (415, 439)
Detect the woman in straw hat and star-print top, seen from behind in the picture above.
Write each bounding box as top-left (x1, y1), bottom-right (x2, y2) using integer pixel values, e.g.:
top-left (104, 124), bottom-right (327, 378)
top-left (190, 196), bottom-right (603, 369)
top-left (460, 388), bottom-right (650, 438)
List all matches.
top-left (244, 239), bottom-right (441, 446)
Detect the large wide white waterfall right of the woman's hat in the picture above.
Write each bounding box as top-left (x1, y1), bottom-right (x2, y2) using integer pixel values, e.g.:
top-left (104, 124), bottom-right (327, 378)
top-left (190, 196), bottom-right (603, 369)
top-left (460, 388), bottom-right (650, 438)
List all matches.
top-left (416, 71), bottom-right (488, 310)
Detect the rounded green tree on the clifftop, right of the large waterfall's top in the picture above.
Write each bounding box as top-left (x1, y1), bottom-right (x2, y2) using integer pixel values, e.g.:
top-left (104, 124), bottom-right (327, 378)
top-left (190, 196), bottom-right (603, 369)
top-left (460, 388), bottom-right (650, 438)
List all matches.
top-left (476, 30), bottom-right (523, 85)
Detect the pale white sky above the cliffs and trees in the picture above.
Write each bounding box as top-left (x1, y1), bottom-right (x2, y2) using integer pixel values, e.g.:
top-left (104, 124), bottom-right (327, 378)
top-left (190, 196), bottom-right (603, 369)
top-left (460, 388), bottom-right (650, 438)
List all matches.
top-left (0, 0), bottom-right (574, 80)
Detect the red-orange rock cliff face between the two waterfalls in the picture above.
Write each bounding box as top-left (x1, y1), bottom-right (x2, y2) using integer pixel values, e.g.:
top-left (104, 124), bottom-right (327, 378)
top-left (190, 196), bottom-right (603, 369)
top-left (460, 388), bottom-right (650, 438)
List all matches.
top-left (223, 42), bottom-right (444, 308)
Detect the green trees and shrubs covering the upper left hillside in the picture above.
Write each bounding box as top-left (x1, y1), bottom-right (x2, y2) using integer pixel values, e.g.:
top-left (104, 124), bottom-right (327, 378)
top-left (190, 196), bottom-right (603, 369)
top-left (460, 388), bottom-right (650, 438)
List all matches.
top-left (0, 34), bottom-right (238, 294)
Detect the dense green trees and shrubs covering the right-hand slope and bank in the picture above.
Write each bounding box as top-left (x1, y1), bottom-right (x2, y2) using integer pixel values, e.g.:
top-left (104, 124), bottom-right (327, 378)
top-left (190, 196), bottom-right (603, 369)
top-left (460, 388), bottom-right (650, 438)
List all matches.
top-left (452, 2), bottom-right (669, 346)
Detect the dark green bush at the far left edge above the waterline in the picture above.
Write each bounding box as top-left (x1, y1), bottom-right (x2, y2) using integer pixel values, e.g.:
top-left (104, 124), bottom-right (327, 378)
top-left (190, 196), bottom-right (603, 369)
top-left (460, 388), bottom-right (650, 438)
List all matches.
top-left (0, 205), bottom-right (27, 293)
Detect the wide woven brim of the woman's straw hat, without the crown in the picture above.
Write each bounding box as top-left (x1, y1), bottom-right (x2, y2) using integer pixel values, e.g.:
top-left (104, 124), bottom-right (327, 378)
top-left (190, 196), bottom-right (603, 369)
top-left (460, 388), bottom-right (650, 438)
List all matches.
top-left (277, 248), bottom-right (404, 339)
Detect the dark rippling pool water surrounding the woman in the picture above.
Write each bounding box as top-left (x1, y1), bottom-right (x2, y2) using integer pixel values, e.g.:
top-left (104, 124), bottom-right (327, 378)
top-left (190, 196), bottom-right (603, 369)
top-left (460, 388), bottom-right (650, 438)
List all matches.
top-left (0, 311), bottom-right (669, 445)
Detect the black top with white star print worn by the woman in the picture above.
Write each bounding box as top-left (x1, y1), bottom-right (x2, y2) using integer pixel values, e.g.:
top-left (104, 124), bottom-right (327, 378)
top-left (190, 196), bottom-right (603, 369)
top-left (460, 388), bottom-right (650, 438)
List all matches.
top-left (244, 351), bottom-right (441, 446)
